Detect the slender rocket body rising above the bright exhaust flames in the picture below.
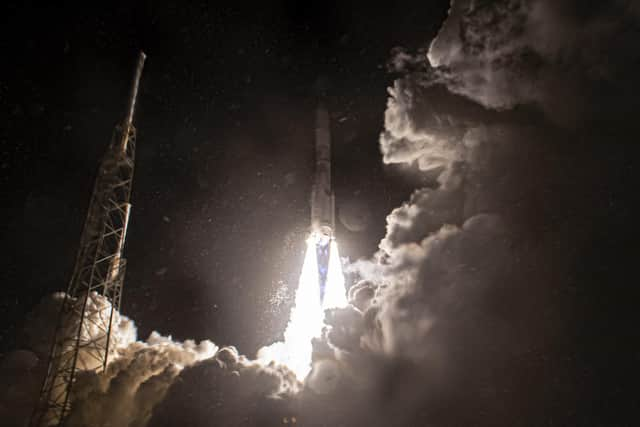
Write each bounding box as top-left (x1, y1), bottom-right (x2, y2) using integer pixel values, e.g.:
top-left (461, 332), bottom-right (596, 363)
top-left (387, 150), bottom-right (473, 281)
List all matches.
top-left (311, 104), bottom-right (335, 239)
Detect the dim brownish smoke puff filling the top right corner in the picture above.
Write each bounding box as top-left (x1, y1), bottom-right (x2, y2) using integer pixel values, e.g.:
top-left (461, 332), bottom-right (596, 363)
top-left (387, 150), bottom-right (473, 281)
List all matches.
top-left (427, 0), bottom-right (638, 125)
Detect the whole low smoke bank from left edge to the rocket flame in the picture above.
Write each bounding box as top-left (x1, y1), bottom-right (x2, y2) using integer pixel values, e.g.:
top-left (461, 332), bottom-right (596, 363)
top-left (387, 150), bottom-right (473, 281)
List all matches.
top-left (0, 293), bottom-right (301, 427)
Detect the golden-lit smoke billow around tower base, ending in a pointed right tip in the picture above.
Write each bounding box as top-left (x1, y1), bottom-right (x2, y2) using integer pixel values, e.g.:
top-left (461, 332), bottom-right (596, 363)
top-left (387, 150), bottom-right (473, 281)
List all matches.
top-left (0, 293), bottom-right (218, 426)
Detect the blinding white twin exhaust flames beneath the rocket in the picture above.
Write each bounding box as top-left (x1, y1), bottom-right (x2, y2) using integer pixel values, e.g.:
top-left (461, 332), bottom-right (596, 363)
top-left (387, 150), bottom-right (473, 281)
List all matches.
top-left (258, 233), bottom-right (347, 380)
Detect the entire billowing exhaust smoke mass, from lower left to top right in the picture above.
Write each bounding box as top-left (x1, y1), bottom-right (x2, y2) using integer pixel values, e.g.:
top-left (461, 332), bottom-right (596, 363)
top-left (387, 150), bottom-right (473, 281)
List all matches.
top-left (0, 0), bottom-right (640, 427)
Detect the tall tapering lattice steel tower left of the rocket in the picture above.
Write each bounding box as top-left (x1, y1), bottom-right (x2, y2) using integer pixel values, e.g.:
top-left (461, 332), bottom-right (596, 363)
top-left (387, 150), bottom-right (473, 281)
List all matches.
top-left (30, 52), bottom-right (146, 427)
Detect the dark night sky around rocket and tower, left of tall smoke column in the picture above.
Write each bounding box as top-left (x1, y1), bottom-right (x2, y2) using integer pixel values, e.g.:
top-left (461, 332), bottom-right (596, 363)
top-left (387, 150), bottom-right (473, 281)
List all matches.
top-left (0, 1), bottom-right (447, 353)
